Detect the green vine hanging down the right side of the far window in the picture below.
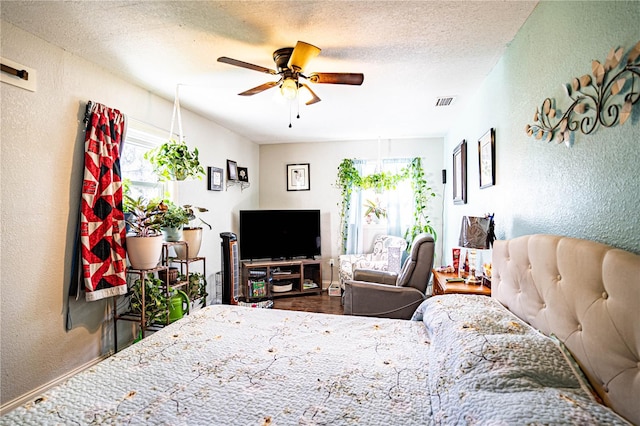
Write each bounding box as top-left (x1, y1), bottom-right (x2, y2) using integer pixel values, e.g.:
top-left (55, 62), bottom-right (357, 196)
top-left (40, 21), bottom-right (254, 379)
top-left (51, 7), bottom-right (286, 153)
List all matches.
top-left (404, 157), bottom-right (437, 250)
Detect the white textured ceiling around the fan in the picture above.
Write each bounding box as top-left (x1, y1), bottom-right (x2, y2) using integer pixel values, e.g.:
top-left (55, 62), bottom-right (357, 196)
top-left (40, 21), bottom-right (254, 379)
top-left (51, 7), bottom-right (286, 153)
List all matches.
top-left (0, 0), bottom-right (537, 143)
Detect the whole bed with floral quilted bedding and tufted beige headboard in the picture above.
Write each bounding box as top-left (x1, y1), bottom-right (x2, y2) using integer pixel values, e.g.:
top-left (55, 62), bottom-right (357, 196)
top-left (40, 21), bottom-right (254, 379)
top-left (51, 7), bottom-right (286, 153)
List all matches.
top-left (0, 235), bottom-right (640, 425)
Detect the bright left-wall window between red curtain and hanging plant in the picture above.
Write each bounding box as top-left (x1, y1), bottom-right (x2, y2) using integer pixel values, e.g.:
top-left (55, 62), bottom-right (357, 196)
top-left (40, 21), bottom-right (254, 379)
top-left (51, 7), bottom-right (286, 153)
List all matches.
top-left (120, 118), bottom-right (168, 200)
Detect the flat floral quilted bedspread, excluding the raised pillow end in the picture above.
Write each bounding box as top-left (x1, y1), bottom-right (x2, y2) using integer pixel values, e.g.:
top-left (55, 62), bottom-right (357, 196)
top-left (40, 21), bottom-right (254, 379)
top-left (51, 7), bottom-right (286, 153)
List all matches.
top-left (0, 305), bottom-right (431, 425)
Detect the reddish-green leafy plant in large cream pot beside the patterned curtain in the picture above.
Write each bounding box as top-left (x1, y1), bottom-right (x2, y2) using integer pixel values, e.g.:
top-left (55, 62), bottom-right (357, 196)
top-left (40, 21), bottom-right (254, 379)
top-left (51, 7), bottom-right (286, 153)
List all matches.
top-left (125, 195), bottom-right (165, 270)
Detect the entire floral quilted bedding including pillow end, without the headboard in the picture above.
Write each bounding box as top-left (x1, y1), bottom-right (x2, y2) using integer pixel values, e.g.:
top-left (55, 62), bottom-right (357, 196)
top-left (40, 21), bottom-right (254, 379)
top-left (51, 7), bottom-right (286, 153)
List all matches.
top-left (0, 295), bottom-right (627, 425)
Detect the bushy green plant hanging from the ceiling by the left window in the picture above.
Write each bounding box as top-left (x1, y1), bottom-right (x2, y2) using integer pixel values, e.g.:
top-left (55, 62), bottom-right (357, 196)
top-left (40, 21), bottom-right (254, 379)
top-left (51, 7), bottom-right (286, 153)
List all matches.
top-left (144, 139), bottom-right (205, 182)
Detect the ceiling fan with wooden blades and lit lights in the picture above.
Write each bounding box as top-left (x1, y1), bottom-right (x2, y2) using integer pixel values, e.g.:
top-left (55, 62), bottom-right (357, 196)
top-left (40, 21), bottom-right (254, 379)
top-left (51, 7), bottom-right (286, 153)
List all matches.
top-left (218, 41), bottom-right (364, 105)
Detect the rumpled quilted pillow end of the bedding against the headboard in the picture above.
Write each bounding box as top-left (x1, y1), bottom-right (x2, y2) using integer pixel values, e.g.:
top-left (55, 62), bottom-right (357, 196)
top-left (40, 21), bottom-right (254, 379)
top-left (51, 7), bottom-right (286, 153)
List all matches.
top-left (414, 295), bottom-right (628, 425)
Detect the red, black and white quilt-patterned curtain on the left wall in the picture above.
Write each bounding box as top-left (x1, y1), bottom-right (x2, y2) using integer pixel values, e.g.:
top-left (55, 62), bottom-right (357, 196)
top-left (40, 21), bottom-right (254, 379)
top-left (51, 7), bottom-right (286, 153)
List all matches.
top-left (80, 102), bottom-right (127, 301)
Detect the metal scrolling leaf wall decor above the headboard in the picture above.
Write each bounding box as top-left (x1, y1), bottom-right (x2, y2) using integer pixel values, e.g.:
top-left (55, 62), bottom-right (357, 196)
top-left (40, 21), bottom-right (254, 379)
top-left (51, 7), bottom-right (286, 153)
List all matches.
top-left (525, 42), bottom-right (640, 147)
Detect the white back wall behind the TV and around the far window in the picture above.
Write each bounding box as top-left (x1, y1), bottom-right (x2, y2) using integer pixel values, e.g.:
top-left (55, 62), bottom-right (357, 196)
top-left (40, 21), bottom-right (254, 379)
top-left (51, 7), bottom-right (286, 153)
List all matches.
top-left (260, 138), bottom-right (444, 286)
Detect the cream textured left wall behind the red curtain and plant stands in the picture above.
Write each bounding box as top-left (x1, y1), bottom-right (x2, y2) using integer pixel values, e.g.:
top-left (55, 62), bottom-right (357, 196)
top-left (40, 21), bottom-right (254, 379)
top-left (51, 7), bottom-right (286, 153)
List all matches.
top-left (0, 21), bottom-right (260, 405)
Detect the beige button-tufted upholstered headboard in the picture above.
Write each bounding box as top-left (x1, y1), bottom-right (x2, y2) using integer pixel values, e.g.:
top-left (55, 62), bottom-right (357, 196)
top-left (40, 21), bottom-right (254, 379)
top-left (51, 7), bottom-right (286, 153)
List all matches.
top-left (492, 235), bottom-right (640, 425)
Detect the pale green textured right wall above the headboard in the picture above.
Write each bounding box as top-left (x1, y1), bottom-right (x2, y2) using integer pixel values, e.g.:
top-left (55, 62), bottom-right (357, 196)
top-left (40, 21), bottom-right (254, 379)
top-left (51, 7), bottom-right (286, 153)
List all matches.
top-left (445, 1), bottom-right (640, 259)
